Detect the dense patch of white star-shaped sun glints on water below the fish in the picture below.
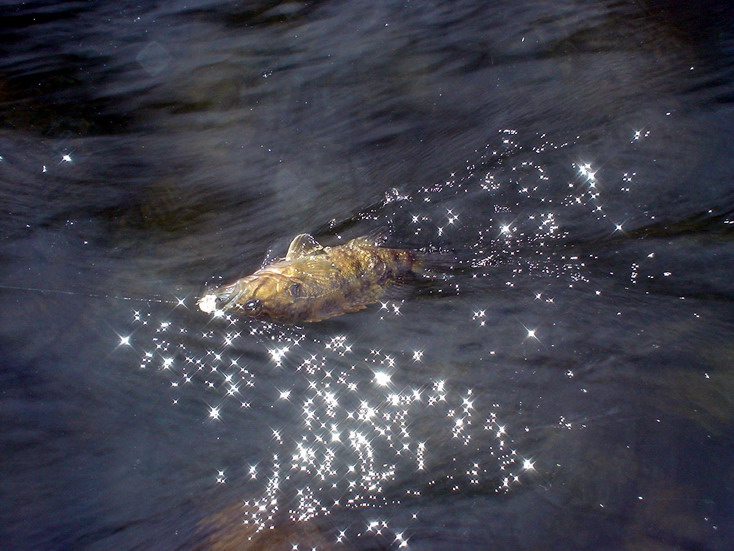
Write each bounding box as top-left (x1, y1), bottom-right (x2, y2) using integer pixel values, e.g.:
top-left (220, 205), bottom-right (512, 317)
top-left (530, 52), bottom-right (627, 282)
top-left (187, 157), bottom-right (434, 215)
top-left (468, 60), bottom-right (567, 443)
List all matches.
top-left (121, 302), bottom-right (535, 546)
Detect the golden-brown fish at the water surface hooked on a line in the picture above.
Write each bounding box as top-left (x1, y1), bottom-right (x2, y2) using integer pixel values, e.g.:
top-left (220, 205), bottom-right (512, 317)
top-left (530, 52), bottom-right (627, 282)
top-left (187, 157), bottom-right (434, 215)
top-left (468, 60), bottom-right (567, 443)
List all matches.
top-left (198, 233), bottom-right (427, 325)
